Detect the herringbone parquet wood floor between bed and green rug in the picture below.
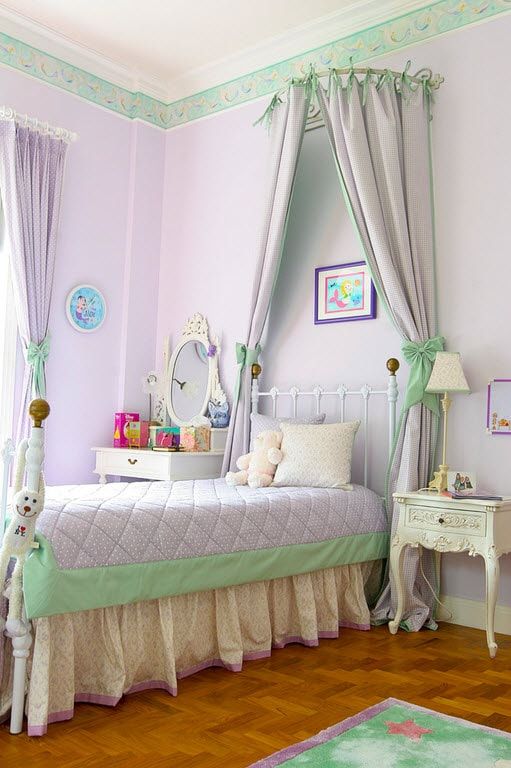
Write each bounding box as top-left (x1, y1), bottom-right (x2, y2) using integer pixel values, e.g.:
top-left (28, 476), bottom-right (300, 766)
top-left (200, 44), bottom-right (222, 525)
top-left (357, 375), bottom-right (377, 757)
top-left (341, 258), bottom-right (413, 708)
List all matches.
top-left (0, 624), bottom-right (511, 768)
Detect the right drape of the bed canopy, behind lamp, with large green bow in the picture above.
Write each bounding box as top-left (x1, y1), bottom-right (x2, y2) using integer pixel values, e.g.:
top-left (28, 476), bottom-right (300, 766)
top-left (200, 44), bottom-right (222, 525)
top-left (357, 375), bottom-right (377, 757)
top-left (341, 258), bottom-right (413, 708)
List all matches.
top-left (317, 75), bottom-right (443, 630)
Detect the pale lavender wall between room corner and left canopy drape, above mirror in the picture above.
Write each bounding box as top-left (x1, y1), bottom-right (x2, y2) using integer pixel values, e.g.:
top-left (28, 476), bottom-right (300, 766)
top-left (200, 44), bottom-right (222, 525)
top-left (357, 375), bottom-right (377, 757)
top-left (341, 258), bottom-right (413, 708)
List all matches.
top-left (157, 103), bottom-right (267, 393)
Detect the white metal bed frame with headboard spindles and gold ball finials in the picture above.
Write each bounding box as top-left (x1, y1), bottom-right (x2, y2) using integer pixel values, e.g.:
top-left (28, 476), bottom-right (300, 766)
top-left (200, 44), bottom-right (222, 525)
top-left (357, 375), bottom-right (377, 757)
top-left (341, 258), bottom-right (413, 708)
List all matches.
top-left (0, 358), bottom-right (399, 734)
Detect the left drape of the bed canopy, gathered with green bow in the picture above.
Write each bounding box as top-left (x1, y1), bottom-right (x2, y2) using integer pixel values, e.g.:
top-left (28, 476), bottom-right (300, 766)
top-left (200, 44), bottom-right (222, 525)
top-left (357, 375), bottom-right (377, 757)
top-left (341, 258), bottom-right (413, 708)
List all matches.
top-left (222, 84), bottom-right (310, 475)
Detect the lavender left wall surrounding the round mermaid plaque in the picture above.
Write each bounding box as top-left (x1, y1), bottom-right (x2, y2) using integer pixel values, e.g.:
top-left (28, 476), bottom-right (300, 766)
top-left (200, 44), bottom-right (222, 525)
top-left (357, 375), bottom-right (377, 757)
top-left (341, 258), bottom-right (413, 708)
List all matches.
top-left (0, 69), bottom-right (164, 483)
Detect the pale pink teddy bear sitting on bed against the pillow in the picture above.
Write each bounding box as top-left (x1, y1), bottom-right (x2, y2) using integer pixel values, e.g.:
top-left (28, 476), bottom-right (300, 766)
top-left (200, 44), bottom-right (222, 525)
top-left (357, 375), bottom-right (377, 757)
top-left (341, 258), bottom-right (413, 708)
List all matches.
top-left (225, 429), bottom-right (282, 488)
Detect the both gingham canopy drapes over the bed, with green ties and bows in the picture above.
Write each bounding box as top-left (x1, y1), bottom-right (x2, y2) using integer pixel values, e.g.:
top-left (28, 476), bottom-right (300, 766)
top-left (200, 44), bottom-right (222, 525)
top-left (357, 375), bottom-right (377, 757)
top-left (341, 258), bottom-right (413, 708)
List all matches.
top-left (240, 64), bottom-right (444, 630)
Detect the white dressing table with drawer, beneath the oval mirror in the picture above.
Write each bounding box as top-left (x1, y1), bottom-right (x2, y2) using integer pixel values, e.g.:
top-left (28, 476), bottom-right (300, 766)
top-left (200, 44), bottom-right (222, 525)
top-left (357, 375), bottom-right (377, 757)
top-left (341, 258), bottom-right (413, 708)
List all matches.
top-left (92, 428), bottom-right (227, 483)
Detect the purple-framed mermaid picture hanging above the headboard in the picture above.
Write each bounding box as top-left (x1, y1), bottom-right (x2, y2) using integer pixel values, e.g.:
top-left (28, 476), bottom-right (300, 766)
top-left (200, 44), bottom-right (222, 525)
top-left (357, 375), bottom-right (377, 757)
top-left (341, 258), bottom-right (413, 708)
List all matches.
top-left (314, 261), bottom-right (376, 325)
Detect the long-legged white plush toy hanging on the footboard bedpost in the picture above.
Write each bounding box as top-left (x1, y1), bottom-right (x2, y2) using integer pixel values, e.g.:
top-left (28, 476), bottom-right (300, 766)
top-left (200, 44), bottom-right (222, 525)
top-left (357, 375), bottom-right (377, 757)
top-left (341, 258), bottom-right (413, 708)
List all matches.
top-left (0, 488), bottom-right (44, 636)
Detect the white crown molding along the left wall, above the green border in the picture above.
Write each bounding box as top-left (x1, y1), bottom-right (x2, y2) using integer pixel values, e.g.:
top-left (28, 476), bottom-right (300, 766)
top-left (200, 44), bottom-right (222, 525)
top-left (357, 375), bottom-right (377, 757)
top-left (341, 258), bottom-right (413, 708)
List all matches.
top-left (0, 2), bottom-right (169, 101)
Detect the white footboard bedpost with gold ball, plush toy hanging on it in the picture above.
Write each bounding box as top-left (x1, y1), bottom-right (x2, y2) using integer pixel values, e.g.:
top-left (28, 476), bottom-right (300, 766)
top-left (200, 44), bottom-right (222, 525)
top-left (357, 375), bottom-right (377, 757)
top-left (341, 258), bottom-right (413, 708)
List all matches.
top-left (10, 400), bottom-right (50, 733)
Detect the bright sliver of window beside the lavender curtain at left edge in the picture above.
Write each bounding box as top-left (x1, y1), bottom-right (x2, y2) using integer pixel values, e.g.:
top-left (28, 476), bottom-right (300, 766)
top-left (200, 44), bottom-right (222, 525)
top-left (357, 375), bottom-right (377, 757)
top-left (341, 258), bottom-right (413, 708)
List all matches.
top-left (0, 205), bottom-right (17, 446)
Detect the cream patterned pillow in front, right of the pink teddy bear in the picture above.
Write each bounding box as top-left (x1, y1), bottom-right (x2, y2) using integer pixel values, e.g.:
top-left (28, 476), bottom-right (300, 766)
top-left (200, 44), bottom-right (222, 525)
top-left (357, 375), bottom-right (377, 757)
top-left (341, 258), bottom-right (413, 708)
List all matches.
top-left (273, 421), bottom-right (360, 490)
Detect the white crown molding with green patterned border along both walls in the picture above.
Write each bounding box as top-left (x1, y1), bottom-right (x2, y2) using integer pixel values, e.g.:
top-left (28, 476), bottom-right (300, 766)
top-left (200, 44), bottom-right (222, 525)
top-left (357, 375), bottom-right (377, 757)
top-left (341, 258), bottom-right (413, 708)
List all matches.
top-left (0, 0), bottom-right (511, 129)
